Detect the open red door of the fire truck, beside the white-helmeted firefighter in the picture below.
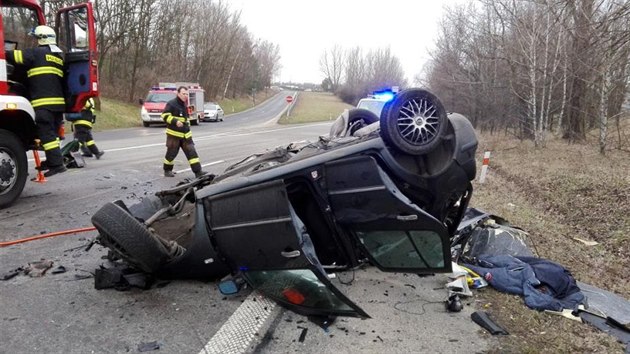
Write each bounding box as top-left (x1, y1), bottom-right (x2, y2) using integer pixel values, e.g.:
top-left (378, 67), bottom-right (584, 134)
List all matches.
top-left (55, 2), bottom-right (99, 112)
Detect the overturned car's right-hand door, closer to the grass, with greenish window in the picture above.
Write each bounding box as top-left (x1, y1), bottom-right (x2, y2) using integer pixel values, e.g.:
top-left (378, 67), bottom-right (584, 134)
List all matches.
top-left (325, 156), bottom-right (451, 274)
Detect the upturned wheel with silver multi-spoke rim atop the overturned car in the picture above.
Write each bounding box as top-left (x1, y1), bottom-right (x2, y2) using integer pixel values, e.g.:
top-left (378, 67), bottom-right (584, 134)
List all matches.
top-left (381, 89), bottom-right (448, 155)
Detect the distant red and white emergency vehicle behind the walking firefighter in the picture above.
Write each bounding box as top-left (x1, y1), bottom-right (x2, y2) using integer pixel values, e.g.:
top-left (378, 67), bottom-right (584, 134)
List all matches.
top-left (140, 82), bottom-right (204, 127)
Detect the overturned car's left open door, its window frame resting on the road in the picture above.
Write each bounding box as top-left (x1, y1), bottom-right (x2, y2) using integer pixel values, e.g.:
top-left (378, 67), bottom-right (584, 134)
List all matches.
top-left (204, 180), bottom-right (369, 317)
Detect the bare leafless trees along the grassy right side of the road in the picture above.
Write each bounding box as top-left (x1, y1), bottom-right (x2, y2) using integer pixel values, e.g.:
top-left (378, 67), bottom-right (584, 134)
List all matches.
top-left (320, 0), bottom-right (630, 153)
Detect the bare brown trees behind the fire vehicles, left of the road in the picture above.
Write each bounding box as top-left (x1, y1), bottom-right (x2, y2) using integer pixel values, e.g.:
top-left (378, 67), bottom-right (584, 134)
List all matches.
top-left (41, 0), bottom-right (280, 101)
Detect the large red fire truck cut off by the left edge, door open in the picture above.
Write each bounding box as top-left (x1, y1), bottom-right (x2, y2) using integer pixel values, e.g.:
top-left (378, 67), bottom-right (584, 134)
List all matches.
top-left (0, 0), bottom-right (99, 208)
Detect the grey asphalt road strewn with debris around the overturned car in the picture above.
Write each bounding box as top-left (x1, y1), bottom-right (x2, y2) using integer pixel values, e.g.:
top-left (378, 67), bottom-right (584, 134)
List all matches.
top-left (0, 92), bottom-right (489, 353)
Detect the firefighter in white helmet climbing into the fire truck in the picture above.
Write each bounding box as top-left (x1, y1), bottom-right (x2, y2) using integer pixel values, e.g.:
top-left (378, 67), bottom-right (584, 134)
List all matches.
top-left (5, 26), bottom-right (66, 177)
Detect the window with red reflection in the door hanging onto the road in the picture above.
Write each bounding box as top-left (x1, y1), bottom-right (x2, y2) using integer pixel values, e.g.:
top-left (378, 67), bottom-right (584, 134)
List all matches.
top-left (245, 269), bottom-right (354, 314)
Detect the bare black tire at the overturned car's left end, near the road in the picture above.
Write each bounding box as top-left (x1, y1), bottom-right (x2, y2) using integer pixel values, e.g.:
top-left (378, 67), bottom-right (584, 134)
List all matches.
top-left (92, 203), bottom-right (168, 273)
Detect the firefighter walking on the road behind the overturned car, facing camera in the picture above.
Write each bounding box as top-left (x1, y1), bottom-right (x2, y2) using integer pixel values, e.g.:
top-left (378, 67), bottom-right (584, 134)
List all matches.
top-left (162, 86), bottom-right (205, 177)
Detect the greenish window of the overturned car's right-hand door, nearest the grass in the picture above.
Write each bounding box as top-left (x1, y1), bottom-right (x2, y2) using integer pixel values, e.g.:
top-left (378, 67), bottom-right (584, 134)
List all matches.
top-left (357, 230), bottom-right (445, 268)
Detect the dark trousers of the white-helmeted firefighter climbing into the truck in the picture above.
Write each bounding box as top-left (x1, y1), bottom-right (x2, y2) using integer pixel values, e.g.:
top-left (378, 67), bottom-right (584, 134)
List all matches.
top-left (35, 108), bottom-right (63, 168)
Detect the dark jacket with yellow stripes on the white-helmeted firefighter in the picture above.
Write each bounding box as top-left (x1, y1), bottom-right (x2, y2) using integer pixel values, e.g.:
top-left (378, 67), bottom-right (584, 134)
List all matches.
top-left (6, 45), bottom-right (66, 112)
